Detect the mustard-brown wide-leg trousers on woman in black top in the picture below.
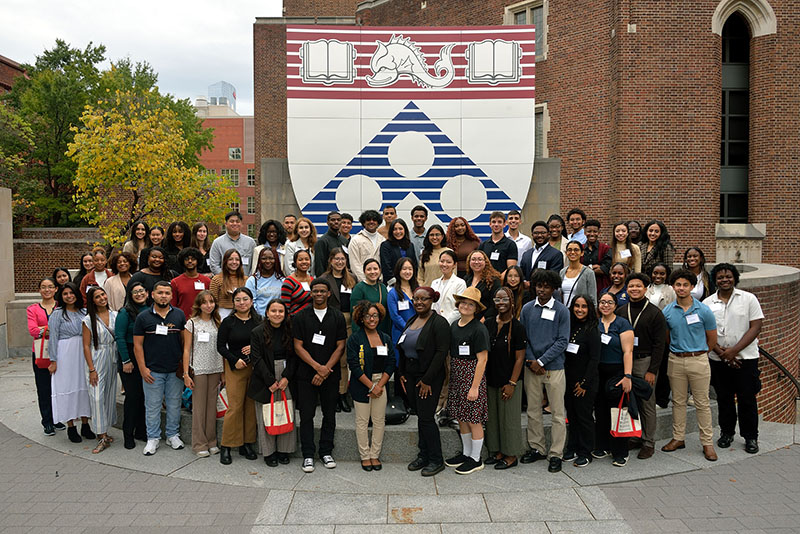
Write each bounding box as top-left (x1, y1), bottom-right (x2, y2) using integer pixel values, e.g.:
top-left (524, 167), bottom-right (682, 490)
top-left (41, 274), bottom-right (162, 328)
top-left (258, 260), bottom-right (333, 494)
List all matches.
top-left (222, 360), bottom-right (257, 447)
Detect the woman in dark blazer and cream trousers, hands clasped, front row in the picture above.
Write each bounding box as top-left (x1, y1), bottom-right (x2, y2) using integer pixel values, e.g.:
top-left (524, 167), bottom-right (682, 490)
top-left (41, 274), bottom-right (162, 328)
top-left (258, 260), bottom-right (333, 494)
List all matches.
top-left (347, 301), bottom-right (395, 471)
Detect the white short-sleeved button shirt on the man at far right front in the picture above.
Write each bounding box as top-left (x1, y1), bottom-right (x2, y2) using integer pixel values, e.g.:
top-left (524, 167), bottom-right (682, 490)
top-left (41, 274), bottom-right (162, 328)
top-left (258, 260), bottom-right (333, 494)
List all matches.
top-left (703, 288), bottom-right (764, 361)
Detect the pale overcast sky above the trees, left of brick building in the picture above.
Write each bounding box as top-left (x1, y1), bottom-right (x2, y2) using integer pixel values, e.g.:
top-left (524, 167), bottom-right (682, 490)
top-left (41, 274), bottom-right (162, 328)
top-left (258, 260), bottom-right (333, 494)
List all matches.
top-left (0, 0), bottom-right (282, 115)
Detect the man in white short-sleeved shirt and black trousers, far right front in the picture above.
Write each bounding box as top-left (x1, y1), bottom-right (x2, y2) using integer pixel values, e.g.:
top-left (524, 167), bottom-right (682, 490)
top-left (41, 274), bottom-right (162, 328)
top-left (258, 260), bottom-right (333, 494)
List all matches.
top-left (703, 263), bottom-right (764, 454)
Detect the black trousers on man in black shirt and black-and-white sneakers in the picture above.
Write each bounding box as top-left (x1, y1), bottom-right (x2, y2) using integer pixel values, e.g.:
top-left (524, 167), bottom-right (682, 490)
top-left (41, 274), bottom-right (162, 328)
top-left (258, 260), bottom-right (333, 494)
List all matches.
top-left (296, 371), bottom-right (341, 458)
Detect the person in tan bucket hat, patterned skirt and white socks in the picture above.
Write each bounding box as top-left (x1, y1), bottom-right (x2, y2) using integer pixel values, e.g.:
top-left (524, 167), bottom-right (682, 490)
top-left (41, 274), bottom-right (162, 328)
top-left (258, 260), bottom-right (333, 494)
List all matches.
top-left (445, 287), bottom-right (489, 475)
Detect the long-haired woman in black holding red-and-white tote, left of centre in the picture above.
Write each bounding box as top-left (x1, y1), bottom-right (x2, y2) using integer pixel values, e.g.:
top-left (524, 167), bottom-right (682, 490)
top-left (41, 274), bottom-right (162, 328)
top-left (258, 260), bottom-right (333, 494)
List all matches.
top-left (247, 298), bottom-right (297, 467)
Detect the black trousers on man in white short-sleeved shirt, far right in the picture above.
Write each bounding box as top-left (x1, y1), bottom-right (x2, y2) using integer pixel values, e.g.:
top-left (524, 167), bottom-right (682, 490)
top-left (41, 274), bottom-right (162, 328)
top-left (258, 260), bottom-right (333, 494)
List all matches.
top-left (710, 359), bottom-right (761, 439)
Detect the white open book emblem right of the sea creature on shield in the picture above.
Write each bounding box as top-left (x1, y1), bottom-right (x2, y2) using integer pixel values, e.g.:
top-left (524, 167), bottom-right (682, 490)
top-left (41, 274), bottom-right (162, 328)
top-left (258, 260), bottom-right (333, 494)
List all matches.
top-left (466, 39), bottom-right (522, 85)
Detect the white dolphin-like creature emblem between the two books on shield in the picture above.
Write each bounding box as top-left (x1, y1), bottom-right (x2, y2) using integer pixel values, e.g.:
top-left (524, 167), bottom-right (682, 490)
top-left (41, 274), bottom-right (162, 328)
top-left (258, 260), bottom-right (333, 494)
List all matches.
top-left (366, 34), bottom-right (455, 88)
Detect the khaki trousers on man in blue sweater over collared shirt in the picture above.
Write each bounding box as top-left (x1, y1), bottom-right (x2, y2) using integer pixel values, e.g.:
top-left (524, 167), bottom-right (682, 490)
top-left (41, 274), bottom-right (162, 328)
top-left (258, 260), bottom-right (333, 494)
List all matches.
top-left (525, 367), bottom-right (567, 458)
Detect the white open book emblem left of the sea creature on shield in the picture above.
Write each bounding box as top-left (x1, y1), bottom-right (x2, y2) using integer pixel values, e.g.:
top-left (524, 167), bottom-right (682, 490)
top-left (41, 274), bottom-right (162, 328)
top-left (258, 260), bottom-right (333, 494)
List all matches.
top-left (300, 39), bottom-right (356, 85)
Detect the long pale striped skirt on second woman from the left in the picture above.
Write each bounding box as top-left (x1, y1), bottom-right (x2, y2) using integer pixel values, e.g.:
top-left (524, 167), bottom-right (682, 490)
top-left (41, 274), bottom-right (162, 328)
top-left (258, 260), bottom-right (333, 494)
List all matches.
top-left (50, 336), bottom-right (92, 423)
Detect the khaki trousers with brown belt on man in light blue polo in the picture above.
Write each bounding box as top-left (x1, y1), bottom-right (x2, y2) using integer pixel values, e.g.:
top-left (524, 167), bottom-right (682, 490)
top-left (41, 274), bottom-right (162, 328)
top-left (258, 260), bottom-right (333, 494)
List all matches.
top-left (667, 353), bottom-right (714, 446)
